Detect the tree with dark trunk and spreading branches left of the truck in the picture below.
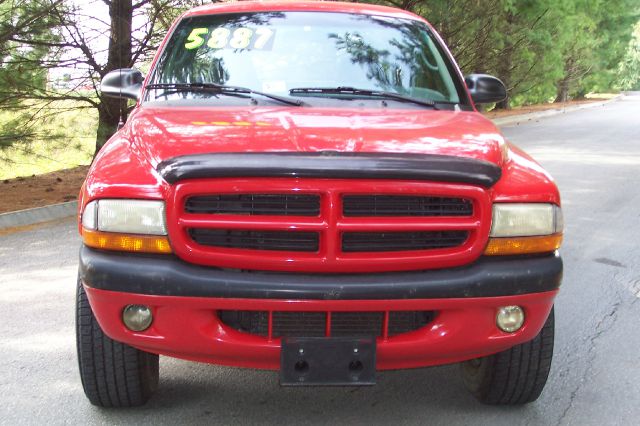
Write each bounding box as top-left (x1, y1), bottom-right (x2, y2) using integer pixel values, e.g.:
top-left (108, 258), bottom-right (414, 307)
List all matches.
top-left (0, 0), bottom-right (211, 153)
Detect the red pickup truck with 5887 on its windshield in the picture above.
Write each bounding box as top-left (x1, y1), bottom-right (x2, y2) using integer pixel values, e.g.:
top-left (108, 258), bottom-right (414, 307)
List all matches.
top-left (76, 2), bottom-right (563, 407)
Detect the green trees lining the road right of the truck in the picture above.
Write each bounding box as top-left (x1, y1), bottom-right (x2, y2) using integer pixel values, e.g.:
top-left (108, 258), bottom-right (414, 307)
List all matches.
top-left (371, 0), bottom-right (638, 108)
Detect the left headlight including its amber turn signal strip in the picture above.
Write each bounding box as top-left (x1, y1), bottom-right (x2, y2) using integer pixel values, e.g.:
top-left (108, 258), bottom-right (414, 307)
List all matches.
top-left (82, 199), bottom-right (171, 253)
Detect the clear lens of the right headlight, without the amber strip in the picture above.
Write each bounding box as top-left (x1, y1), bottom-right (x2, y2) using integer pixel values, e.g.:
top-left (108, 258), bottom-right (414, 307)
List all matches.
top-left (490, 203), bottom-right (563, 237)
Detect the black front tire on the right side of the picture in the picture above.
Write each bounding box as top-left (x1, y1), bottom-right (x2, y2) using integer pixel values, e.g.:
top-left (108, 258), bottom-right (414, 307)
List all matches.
top-left (461, 308), bottom-right (554, 405)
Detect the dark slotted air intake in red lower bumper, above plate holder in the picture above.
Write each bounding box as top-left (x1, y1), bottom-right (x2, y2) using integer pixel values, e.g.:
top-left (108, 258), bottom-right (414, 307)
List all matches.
top-left (218, 310), bottom-right (436, 337)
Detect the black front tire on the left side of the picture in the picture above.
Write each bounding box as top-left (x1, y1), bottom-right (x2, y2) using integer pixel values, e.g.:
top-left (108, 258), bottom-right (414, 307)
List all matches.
top-left (76, 280), bottom-right (159, 407)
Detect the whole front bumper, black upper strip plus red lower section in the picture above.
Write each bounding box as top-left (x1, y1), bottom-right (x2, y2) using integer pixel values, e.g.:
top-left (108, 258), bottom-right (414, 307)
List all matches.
top-left (80, 247), bottom-right (562, 370)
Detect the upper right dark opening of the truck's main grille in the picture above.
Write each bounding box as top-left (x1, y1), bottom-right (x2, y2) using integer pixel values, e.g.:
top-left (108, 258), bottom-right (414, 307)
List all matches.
top-left (342, 195), bottom-right (473, 217)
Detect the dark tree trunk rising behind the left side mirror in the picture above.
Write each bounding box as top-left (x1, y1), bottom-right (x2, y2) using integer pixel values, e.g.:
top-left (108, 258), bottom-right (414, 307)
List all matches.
top-left (95, 0), bottom-right (133, 154)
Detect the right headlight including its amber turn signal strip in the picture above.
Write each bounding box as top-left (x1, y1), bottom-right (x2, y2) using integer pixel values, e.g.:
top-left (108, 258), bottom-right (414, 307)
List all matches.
top-left (484, 203), bottom-right (564, 256)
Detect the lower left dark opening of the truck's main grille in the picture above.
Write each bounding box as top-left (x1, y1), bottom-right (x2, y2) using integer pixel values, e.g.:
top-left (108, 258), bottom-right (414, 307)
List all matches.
top-left (189, 228), bottom-right (319, 252)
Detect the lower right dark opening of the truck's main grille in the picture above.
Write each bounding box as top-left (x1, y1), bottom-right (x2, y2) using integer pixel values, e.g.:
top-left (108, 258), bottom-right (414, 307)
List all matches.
top-left (342, 231), bottom-right (469, 253)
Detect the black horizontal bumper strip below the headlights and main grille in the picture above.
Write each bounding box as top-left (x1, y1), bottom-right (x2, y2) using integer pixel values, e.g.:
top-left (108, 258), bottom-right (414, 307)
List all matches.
top-left (80, 246), bottom-right (562, 300)
